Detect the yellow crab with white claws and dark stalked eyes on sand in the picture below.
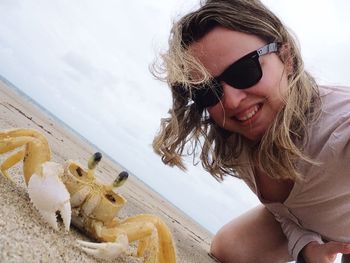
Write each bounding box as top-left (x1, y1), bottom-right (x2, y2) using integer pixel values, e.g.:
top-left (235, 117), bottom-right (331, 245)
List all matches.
top-left (0, 129), bottom-right (176, 263)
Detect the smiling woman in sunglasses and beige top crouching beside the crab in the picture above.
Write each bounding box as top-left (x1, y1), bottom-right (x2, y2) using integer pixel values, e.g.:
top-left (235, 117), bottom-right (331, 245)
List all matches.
top-left (153, 0), bottom-right (350, 262)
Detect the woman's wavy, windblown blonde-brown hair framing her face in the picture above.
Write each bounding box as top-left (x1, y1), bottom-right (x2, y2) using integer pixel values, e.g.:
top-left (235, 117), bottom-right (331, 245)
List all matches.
top-left (153, 0), bottom-right (320, 183)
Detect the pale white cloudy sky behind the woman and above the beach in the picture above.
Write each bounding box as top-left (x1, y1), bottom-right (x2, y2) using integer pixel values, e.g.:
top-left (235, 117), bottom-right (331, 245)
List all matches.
top-left (0, 0), bottom-right (350, 250)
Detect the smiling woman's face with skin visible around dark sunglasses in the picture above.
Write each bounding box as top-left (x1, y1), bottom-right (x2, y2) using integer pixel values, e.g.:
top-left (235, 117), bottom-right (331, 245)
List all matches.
top-left (189, 27), bottom-right (288, 141)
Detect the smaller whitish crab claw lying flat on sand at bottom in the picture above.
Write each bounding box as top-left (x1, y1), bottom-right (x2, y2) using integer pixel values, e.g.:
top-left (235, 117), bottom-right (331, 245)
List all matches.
top-left (77, 235), bottom-right (129, 260)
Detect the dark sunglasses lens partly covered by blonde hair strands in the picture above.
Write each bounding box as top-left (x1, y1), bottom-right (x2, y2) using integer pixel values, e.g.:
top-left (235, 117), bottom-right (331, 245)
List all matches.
top-left (192, 79), bottom-right (223, 108)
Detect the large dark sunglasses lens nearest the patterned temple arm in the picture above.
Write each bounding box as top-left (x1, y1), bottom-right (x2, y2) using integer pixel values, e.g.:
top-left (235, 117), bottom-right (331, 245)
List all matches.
top-left (220, 57), bottom-right (262, 89)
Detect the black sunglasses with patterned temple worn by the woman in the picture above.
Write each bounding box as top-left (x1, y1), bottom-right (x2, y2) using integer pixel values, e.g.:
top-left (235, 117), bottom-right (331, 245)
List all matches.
top-left (177, 43), bottom-right (278, 109)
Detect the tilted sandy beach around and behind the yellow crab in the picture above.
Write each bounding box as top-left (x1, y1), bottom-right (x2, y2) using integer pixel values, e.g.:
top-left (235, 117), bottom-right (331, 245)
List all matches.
top-left (0, 81), bottom-right (219, 263)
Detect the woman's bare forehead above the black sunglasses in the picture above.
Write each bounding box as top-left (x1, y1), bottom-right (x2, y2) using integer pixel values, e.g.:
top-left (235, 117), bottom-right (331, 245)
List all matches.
top-left (189, 27), bottom-right (265, 76)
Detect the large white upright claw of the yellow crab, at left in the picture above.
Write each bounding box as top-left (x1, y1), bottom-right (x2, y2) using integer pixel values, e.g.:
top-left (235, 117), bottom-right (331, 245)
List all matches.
top-left (28, 162), bottom-right (71, 231)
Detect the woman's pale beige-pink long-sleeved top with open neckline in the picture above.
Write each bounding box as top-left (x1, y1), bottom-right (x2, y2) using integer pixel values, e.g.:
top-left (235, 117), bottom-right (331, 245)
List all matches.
top-left (244, 87), bottom-right (350, 260)
